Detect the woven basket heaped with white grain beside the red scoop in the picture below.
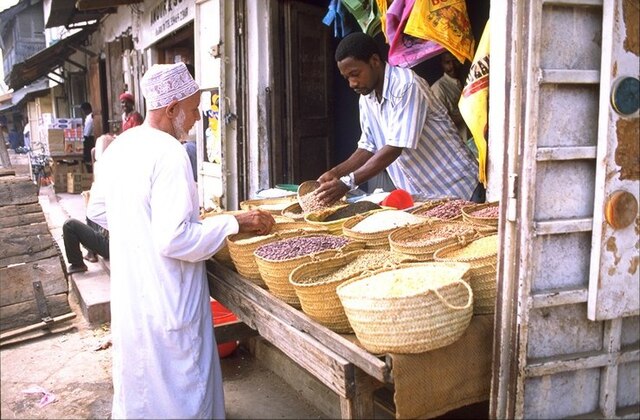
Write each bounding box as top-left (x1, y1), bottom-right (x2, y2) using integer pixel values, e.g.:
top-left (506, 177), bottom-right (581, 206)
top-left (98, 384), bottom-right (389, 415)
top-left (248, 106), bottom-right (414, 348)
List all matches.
top-left (342, 209), bottom-right (425, 250)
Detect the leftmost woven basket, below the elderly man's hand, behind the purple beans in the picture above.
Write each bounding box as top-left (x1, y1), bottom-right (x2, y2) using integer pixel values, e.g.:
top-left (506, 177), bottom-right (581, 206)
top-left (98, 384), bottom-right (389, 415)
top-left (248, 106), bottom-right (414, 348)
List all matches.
top-left (227, 222), bottom-right (327, 287)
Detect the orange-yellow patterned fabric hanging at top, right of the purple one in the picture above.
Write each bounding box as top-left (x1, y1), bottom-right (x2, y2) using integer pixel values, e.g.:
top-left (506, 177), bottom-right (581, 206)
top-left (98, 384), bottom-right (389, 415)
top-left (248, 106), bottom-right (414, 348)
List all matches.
top-left (404, 0), bottom-right (475, 63)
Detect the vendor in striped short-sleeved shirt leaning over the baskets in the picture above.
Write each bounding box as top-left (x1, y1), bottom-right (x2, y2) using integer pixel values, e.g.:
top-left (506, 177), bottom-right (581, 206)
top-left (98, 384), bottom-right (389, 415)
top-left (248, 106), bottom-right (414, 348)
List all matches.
top-left (317, 32), bottom-right (478, 204)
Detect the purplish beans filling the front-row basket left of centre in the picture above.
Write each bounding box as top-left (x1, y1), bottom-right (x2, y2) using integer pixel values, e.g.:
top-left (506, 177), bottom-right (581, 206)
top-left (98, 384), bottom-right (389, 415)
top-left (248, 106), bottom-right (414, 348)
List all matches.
top-left (255, 235), bottom-right (349, 261)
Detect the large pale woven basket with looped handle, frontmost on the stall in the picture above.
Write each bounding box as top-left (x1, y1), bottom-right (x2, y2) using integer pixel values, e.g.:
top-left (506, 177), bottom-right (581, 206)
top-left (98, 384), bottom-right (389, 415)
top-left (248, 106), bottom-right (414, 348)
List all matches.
top-left (336, 262), bottom-right (473, 353)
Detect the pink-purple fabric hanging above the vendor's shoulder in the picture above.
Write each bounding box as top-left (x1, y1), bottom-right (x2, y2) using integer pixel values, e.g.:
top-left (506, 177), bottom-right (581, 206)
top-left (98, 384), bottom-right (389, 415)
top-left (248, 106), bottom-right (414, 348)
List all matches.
top-left (386, 0), bottom-right (444, 67)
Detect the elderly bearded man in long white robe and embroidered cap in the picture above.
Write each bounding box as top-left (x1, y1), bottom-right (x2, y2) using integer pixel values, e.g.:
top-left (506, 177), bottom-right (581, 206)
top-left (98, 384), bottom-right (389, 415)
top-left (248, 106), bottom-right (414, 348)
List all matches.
top-left (87, 63), bottom-right (275, 419)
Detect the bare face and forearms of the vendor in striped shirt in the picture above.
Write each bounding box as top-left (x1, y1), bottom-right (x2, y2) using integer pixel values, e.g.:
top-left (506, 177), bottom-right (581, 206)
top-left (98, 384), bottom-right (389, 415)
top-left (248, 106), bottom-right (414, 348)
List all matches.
top-left (317, 50), bottom-right (403, 204)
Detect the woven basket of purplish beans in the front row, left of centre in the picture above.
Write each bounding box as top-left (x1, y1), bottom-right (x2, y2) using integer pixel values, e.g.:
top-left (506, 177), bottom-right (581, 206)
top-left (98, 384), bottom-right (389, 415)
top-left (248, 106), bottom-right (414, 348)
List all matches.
top-left (253, 234), bottom-right (364, 308)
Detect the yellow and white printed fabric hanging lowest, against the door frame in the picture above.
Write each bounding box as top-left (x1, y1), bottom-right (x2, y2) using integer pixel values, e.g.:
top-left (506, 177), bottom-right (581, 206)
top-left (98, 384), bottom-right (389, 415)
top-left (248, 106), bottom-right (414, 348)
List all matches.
top-left (458, 21), bottom-right (489, 187)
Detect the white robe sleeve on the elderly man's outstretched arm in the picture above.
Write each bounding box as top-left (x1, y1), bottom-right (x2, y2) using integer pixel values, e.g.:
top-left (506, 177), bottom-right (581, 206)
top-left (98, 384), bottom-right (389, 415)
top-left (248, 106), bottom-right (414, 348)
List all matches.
top-left (150, 148), bottom-right (239, 262)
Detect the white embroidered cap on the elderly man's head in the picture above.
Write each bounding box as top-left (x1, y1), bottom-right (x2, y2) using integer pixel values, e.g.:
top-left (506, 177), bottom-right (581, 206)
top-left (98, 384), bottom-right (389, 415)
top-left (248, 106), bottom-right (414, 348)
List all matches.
top-left (140, 63), bottom-right (200, 110)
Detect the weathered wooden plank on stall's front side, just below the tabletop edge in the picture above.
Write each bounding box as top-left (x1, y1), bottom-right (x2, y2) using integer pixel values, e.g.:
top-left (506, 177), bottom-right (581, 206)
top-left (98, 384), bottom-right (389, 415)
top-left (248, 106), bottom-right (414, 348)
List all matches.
top-left (230, 288), bottom-right (354, 398)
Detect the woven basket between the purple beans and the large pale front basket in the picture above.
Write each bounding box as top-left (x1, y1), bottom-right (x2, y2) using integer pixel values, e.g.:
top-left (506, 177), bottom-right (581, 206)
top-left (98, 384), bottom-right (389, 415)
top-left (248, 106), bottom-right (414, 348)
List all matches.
top-left (289, 250), bottom-right (404, 334)
